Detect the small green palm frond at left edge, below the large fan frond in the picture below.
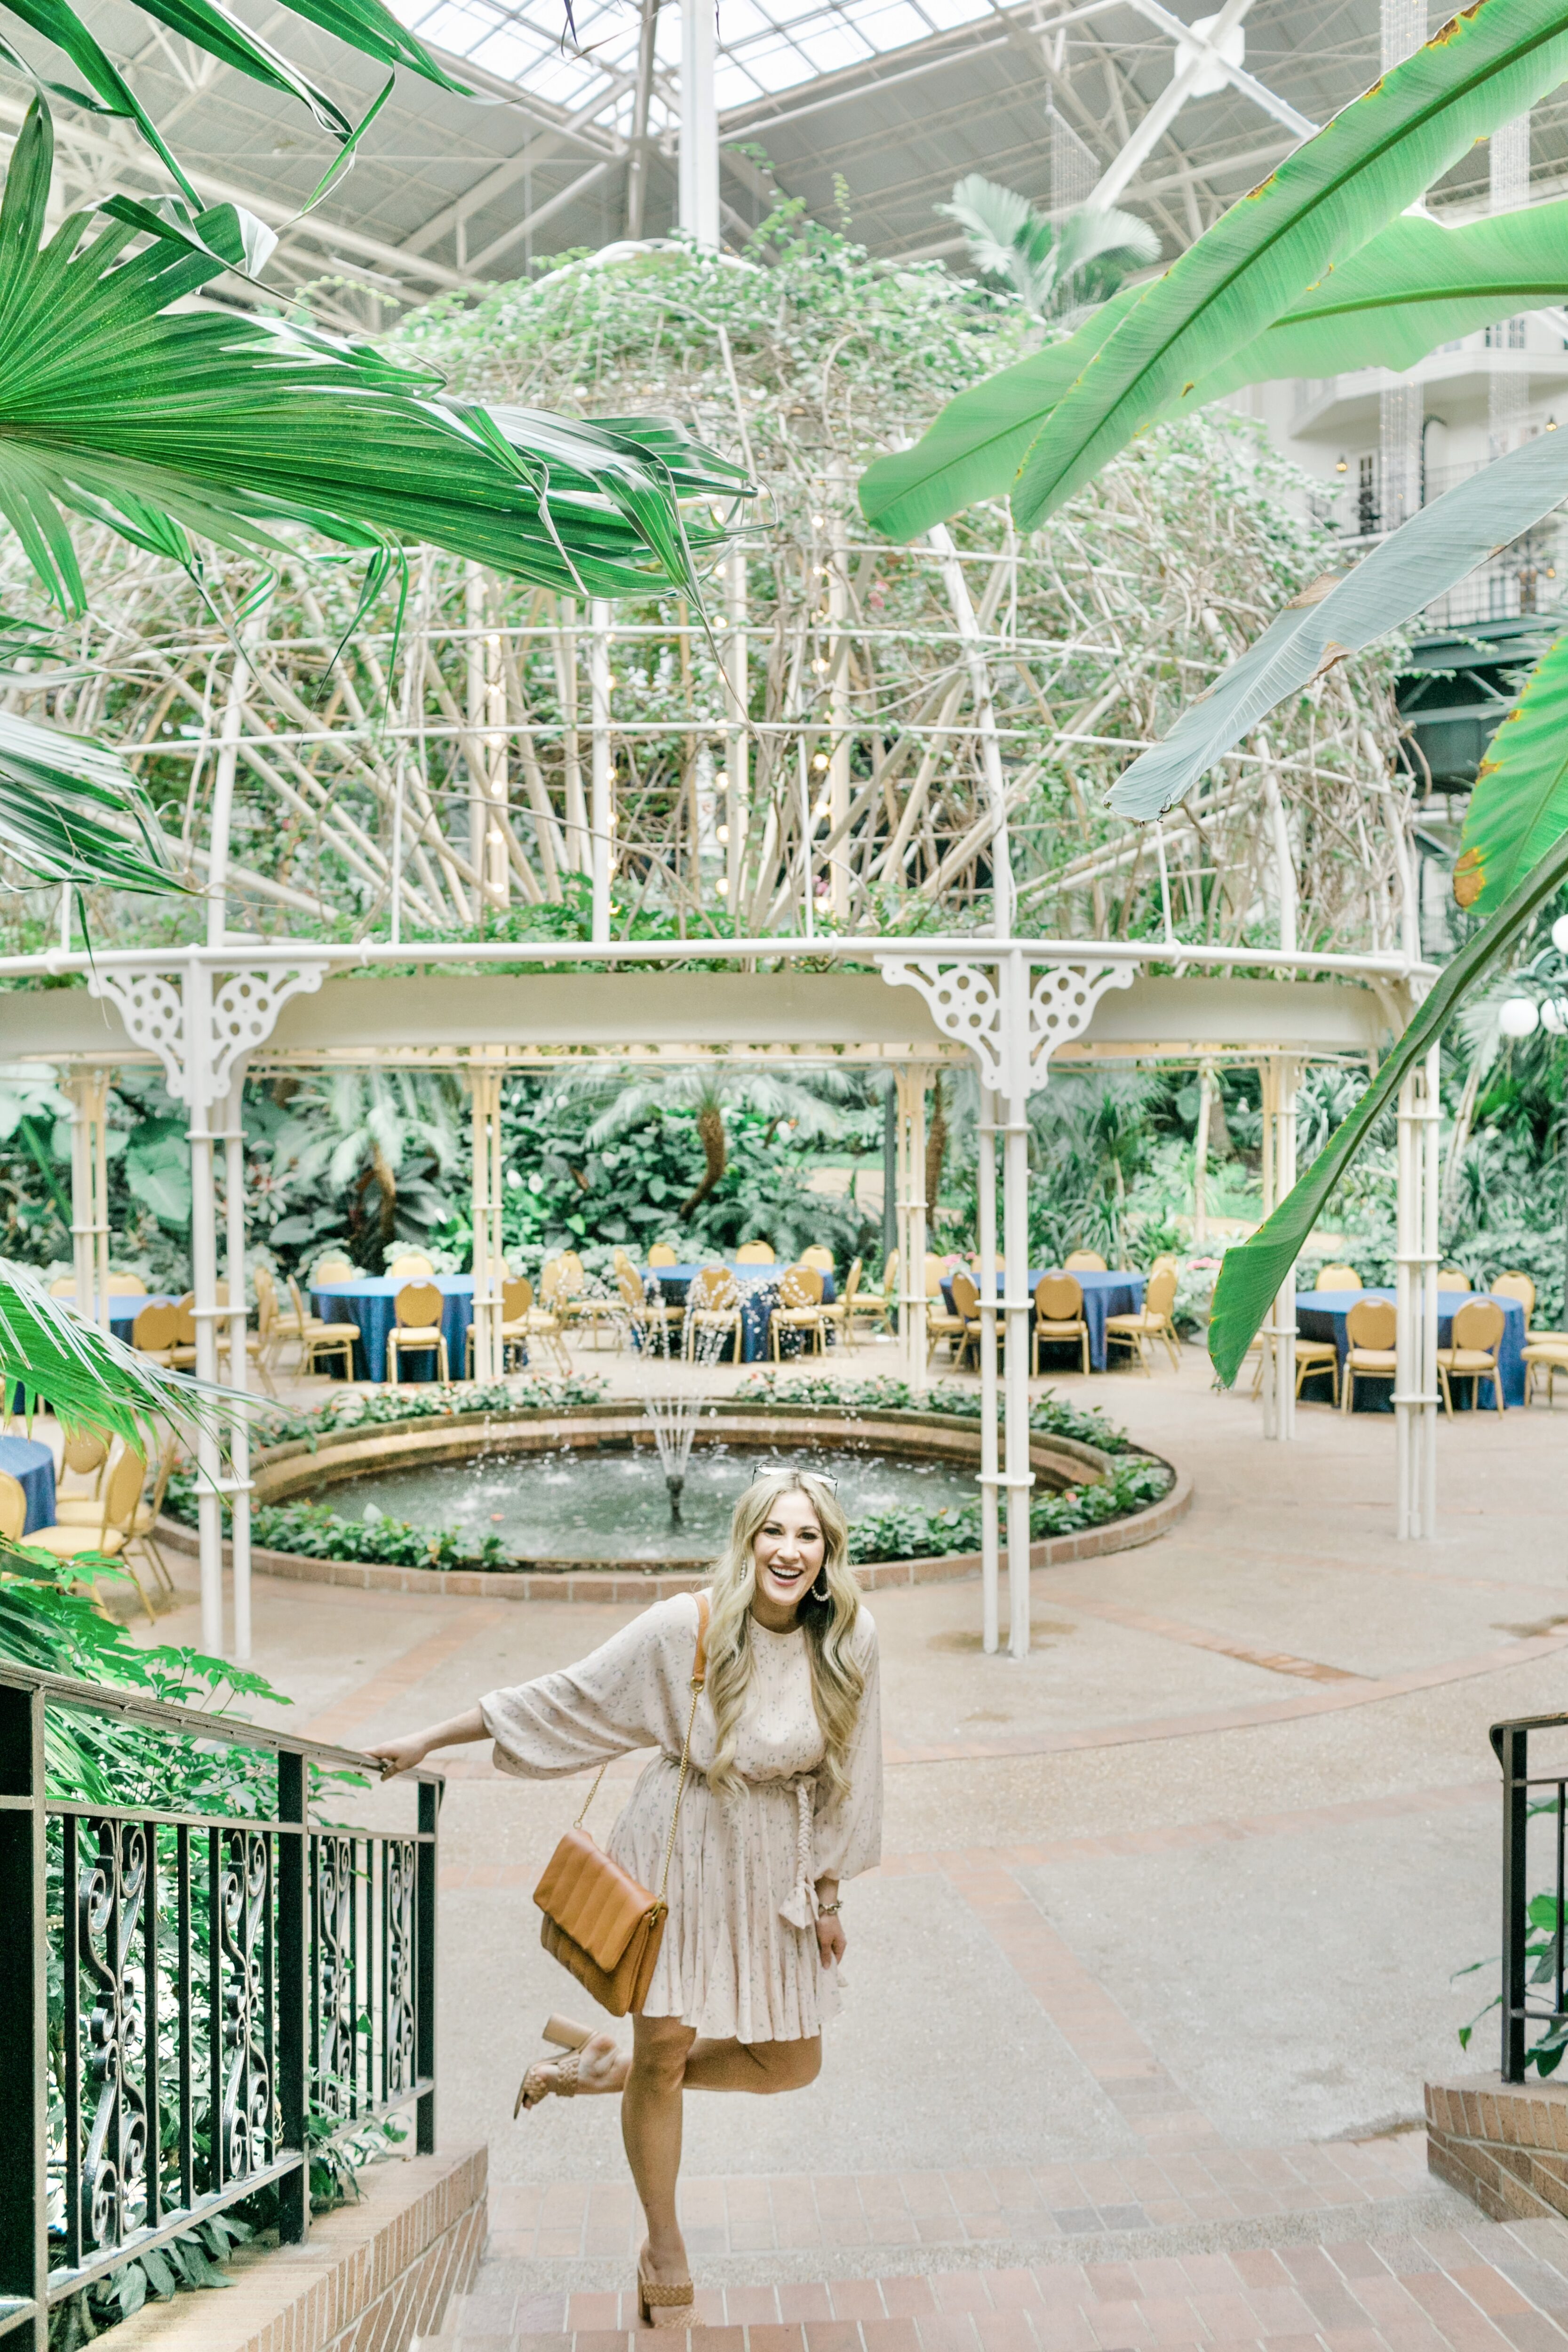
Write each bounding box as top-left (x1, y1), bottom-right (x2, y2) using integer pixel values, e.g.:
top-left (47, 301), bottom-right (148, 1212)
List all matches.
top-left (0, 710), bottom-right (186, 894)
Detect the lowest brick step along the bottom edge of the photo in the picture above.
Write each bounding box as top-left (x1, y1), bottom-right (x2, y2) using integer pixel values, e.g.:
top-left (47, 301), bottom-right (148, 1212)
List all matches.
top-left (439, 2218), bottom-right (1568, 2352)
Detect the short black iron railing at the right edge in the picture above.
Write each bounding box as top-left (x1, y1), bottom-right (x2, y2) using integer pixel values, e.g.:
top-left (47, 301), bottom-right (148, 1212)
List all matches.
top-left (1490, 1715), bottom-right (1568, 2082)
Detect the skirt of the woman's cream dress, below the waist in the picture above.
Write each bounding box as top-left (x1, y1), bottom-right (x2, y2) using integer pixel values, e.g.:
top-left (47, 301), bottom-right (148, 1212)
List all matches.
top-left (609, 1755), bottom-right (839, 2042)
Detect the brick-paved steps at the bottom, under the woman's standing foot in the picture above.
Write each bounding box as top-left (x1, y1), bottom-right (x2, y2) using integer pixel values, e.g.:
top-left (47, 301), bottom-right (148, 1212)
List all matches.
top-left (425, 2136), bottom-right (1568, 2352)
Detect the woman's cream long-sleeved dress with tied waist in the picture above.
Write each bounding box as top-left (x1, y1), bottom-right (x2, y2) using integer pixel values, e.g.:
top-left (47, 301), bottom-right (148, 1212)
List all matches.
top-left (479, 1592), bottom-right (882, 2042)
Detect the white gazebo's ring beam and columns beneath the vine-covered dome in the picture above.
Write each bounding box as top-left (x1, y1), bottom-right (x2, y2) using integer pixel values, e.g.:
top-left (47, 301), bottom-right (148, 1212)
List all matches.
top-left (0, 931), bottom-right (1439, 1658)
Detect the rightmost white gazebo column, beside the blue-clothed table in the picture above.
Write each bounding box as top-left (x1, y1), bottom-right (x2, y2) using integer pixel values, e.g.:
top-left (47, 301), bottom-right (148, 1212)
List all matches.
top-left (1394, 1049), bottom-right (1441, 1543)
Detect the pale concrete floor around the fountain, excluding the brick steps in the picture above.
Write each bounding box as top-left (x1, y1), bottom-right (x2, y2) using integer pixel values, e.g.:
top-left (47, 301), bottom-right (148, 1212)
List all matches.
top-left (131, 1350), bottom-right (1568, 2284)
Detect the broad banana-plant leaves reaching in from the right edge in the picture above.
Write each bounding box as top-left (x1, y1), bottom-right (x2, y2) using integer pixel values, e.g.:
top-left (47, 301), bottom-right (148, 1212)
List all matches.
top-left (846, 0), bottom-right (1568, 1381)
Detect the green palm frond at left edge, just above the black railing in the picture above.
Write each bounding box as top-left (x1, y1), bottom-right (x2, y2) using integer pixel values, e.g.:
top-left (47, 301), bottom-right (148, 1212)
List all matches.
top-left (0, 1261), bottom-right (242, 1451)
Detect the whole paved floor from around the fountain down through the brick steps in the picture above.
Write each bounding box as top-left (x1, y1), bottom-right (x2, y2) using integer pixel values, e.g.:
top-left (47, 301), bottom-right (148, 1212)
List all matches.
top-left (147, 1352), bottom-right (1568, 2352)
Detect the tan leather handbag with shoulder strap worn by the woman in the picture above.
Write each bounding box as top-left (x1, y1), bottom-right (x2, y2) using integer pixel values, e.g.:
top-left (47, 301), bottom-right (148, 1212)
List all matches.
top-left (533, 1592), bottom-right (708, 2018)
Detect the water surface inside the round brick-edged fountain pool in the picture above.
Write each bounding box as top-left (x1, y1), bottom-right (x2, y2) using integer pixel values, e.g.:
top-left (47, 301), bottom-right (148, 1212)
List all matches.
top-left (308, 1444), bottom-right (976, 1562)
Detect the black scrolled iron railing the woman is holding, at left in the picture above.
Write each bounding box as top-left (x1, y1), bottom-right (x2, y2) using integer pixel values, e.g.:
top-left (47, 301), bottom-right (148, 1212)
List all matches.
top-left (0, 1665), bottom-right (442, 2352)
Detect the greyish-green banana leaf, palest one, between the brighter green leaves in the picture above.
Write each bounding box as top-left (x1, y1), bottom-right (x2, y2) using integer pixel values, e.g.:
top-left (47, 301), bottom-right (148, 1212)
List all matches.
top-left (1110, 433), bottom-right (1568, 823)
